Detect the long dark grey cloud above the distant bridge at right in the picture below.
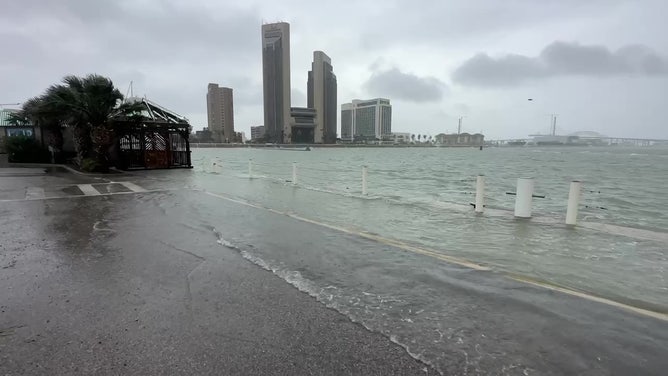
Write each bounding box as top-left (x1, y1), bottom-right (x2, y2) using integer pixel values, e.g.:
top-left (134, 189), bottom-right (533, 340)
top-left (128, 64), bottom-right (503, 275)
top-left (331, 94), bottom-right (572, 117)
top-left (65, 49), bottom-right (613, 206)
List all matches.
top-left (452, 42), bottom-right (668, 86)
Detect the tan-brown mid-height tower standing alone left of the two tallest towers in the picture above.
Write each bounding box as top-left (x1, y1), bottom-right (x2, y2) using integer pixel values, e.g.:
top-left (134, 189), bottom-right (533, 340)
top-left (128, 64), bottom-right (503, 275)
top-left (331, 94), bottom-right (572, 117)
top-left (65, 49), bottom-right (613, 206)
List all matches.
top-left (206, 84), bottom-right (235, 142)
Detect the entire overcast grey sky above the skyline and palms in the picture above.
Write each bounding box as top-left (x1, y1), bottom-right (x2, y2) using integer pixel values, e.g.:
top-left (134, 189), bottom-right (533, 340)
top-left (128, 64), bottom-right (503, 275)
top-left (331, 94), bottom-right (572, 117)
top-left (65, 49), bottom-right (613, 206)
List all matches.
top-left (0, 0), bottom-right (668, 139)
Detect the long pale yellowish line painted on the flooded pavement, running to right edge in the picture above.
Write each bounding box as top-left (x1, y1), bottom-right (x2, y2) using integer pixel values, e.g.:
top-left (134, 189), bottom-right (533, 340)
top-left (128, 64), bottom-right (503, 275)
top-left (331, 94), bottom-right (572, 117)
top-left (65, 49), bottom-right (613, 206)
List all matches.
top-left (203, 191), bottom-right (668, 321)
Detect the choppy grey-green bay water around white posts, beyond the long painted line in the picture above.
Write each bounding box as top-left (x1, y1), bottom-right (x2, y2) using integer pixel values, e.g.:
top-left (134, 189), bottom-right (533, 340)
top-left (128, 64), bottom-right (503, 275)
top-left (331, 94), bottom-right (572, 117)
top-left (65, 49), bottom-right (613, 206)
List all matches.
top-left (193, 146), bottom-right (668, 312)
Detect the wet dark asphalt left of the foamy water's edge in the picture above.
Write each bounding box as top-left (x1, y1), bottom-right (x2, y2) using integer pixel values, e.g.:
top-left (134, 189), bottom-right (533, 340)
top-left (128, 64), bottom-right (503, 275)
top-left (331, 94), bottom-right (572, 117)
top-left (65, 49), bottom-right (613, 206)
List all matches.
top-left (0, 170), bottom-right (435, 375)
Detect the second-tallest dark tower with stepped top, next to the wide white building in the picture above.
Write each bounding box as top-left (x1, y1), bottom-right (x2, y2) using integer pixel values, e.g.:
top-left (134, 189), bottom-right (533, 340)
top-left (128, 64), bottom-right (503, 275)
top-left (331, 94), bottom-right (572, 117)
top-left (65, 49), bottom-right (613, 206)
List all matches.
top-left (307, 51), bottom-right (337, 144)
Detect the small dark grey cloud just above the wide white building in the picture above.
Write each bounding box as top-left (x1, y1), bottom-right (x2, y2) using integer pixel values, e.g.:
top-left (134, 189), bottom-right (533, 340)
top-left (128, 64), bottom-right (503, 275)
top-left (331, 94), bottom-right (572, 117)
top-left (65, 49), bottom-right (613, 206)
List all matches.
top-left (364, 68), bottom-right (447, 103)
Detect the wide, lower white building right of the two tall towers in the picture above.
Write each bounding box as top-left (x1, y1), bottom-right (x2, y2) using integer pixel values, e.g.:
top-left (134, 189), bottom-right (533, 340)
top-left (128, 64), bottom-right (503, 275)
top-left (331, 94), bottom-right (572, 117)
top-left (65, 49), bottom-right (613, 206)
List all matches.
top-left (341, 98), bottom-right (392, 141)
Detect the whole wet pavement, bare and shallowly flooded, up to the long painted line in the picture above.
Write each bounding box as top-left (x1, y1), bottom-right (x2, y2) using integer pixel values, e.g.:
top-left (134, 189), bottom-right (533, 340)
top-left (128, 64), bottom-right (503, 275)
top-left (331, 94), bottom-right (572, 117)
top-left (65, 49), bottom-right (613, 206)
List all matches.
top-left (0, 165), bottom-right (668, 375)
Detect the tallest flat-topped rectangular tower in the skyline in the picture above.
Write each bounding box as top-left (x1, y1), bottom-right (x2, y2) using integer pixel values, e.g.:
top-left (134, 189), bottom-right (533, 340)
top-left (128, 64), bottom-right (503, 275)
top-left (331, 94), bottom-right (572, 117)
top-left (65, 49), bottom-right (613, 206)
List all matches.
top-left (262, 22), bottom-right (291, 143)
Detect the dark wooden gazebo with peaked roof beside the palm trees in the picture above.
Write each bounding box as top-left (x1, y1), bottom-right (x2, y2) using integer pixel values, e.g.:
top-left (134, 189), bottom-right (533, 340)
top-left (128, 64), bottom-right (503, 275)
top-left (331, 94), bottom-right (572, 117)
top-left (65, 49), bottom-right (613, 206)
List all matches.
top-left (113, 97), bottom-right (192, 170)
